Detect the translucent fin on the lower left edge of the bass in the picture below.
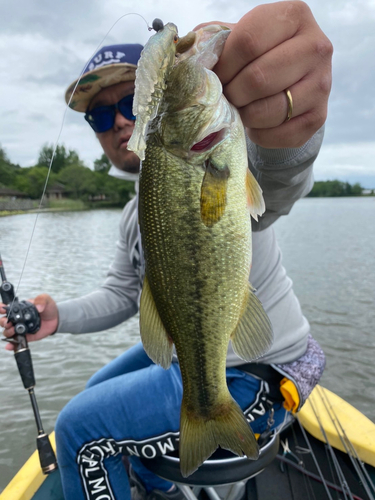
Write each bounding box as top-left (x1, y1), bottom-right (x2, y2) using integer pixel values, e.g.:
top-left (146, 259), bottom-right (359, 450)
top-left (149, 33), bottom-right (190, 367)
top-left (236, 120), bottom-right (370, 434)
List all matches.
top-left (139, 277), bottom-right (173, 368)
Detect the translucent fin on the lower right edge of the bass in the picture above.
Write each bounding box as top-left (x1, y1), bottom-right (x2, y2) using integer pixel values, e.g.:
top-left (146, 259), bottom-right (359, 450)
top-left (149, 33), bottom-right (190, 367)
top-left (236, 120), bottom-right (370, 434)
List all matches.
top-left (231, 283), bottom-right (273, 361)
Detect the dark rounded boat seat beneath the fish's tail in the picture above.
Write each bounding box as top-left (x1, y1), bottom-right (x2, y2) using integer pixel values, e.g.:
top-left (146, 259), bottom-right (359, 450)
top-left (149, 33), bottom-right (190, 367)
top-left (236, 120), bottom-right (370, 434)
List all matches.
top-left (141, 432), bottom-right (280, 500)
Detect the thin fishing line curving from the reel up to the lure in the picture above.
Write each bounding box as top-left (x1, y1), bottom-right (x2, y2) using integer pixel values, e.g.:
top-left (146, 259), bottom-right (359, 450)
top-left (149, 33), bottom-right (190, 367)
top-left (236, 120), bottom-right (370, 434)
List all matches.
top-left (10, 12), bottom-right (153, 312)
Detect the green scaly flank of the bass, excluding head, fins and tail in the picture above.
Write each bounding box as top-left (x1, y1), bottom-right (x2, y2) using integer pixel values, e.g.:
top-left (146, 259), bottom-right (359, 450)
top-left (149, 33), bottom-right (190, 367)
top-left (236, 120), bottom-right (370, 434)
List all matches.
top-left (140, 134), bottom-right (251, 415)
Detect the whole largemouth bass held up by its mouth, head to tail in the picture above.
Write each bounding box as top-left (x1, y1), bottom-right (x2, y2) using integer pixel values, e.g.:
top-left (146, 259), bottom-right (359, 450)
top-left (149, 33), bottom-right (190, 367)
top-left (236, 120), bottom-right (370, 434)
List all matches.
top-left (133, 24), bottom-right (273, 477)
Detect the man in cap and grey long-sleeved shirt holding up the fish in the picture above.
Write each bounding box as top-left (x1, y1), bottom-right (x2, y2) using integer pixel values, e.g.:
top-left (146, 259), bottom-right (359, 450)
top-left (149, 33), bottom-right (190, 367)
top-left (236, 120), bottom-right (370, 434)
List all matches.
top-left (0, 2), bottom-right (332, 500)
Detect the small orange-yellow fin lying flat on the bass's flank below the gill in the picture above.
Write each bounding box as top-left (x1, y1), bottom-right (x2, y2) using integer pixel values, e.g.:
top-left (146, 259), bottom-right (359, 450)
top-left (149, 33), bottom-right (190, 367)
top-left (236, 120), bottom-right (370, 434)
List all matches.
top-left (201, 160), bottom-right (229, 227)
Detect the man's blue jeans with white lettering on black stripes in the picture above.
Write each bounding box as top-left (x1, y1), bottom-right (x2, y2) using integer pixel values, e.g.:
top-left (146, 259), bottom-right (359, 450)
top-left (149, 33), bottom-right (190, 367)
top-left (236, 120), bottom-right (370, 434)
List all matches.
top-left (56, 343), bottom-right (285, 500)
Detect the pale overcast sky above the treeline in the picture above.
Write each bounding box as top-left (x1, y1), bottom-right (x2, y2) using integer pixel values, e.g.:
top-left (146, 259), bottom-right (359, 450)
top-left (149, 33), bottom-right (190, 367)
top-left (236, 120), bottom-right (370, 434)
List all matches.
top-left (0, 0), bottom-right (375, 188)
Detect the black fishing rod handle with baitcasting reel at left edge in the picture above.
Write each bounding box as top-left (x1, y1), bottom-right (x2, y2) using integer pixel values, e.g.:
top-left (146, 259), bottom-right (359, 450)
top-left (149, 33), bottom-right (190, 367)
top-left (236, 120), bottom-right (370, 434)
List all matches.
top-left (0, 255), bottom-right (57, 474)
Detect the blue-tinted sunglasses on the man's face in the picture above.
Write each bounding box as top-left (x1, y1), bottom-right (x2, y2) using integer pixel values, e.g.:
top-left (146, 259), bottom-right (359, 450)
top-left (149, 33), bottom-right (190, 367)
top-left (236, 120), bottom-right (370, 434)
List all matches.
top-left (85, 94), bottom-right (135, 133)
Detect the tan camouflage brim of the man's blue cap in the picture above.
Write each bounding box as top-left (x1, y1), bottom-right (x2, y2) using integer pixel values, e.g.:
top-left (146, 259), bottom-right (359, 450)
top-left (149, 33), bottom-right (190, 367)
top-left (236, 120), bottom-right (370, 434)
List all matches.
top-left (65, 63), bottom-right (137, 113)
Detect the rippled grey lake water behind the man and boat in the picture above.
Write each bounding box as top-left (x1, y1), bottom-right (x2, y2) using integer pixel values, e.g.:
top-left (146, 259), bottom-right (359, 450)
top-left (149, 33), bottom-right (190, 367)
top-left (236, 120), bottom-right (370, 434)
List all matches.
top-left (0, 198), bottom-right (375, 491)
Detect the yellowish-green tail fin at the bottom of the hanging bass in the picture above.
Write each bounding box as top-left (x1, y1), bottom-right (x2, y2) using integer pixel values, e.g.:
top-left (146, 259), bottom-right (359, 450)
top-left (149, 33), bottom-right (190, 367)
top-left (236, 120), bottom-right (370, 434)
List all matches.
top-left (179, 393), bottom-right (259, 477)
